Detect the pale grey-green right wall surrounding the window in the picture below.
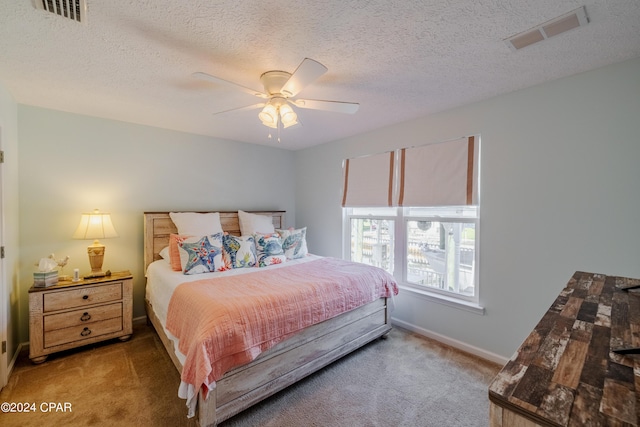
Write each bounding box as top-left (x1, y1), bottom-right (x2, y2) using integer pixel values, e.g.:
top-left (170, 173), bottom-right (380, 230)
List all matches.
top-left (295, 59), bottom-right (640, 358)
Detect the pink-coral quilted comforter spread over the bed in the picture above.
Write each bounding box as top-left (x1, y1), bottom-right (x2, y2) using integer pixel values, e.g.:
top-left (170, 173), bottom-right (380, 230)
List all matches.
top-left (167, 258), bottom-right (398, 400)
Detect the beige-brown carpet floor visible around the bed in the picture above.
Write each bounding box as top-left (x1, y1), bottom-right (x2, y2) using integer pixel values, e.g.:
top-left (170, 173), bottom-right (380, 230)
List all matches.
top-left (0, 325), bottom-right (500, 427)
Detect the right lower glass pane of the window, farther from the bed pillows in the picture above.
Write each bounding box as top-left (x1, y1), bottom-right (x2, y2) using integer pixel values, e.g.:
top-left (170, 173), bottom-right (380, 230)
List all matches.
top-left (407, 221), bottom-right (476, 296)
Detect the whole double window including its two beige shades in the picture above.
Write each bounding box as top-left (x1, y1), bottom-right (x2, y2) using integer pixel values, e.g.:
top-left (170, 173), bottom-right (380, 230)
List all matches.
top-left (342, 136), bottom-right (481, 311)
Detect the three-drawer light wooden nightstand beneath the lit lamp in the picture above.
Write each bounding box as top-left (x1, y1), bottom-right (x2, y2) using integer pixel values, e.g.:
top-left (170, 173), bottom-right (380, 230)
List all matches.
top-left (29, 271), bottom-right (133, 363)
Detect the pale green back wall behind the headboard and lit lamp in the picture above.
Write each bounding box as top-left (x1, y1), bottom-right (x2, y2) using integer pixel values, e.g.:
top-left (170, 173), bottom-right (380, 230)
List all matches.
top-left (18, 105), bottom-right (295, 342)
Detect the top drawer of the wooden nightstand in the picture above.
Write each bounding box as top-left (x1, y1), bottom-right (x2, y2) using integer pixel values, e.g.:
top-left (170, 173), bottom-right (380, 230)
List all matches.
top-left (43, 282), bottom-right (122, 312)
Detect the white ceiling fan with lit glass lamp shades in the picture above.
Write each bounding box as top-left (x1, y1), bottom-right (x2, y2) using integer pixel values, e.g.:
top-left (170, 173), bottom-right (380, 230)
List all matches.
top-left (192, 58), bottom-right (360, 129)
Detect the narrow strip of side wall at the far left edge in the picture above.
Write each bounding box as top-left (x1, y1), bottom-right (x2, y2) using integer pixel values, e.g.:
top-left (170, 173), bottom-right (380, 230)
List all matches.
top-left (0, 84), bottom-right (20, 376)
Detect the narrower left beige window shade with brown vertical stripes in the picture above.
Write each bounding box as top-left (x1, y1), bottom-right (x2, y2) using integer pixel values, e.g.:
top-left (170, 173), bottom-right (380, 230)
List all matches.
top-left (342, 152), bottom-right (394, 207)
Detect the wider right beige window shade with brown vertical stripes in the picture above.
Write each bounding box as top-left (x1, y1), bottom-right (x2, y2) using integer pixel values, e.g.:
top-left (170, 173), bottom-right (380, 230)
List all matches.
top-left (397, 136), bottom-right (477, 206)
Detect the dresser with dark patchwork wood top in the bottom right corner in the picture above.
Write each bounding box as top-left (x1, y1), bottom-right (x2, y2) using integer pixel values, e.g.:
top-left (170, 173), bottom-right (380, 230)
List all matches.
top-left (489, 272), bottom-right (640, 427)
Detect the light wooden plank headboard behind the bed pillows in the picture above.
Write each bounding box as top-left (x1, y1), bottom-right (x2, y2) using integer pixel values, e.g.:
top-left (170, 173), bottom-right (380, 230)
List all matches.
top-left (144, 211), bottom-right (284, 271)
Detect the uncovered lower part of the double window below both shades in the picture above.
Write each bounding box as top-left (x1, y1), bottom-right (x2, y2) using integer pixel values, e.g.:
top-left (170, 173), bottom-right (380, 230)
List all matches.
top-left (344, 206), bottom-right (479, 303)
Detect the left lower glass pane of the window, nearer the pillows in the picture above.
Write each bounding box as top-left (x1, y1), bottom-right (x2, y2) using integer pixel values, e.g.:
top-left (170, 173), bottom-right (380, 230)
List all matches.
top-left (351, 218), bottom-right (394, 274)
